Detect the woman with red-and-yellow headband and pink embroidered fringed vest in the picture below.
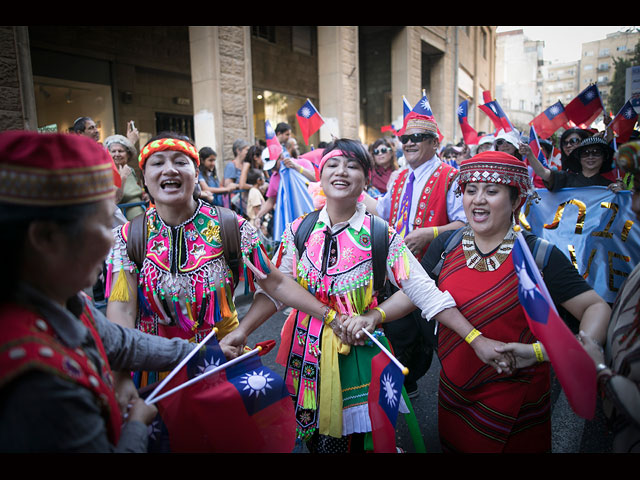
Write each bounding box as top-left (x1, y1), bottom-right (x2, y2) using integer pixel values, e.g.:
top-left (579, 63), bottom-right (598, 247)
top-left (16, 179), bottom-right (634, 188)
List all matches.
top-left (106, 134), bottom-right (324, 386)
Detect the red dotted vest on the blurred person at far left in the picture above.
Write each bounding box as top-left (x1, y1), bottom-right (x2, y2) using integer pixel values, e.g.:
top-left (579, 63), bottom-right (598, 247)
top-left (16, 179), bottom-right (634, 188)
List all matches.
top-left (0, 298), bottom-right (122, 444)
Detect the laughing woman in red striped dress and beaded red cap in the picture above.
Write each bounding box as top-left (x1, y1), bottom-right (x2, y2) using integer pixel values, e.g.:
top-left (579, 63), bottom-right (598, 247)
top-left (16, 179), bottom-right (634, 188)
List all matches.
top-left (422, 151), bottom-right (610, 453)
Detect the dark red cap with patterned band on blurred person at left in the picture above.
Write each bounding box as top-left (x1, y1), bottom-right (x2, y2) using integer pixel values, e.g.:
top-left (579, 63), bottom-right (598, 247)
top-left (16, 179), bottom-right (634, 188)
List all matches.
top-left (0, 130), bottom-right (115, 206)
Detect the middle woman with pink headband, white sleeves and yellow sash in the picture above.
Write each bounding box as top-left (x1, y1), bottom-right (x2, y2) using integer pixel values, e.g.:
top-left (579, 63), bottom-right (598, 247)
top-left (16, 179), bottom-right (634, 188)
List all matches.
top-left (223, 139), bottom-right (516, 453)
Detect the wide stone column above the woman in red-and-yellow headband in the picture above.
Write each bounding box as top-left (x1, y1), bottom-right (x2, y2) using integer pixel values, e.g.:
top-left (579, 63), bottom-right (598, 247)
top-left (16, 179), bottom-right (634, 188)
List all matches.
top-left (189, 26), bottom-right (254, 175)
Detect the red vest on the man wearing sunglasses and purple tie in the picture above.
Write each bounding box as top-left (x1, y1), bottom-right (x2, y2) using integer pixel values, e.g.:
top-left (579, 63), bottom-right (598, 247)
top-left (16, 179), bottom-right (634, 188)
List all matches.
top-left (389, 162), bottom-right (458, 256)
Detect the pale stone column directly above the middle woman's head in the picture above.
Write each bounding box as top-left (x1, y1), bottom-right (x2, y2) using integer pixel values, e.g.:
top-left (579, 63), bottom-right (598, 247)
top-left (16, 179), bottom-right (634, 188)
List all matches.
top-left (318, 26), bottom-right (360, 142)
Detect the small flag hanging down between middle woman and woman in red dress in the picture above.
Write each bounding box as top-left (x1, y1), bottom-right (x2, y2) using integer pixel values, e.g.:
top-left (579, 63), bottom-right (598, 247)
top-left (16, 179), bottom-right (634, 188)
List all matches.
top-left (368, 352), bottom-right (404, 453)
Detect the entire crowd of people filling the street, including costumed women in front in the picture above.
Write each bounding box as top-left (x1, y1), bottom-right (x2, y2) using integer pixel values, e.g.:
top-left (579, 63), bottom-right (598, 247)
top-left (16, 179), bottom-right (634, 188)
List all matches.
top-left (0, 105), bottom-right (640, 453)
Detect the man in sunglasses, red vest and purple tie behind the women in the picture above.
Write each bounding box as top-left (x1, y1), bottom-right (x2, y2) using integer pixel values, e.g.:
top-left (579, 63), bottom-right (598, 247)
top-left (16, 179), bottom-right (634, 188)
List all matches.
top-left (367, 112), bottom-right (466, 398)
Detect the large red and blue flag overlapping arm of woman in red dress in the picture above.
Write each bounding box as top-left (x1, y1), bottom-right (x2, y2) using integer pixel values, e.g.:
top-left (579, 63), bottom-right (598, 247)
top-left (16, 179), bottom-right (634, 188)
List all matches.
top-left (513, 232), bottom-right (597, 419)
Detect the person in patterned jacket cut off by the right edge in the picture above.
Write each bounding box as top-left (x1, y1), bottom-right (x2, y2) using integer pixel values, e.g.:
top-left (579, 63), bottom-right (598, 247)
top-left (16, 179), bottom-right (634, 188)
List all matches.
top-left (580, 142), bottom-right (640, 453)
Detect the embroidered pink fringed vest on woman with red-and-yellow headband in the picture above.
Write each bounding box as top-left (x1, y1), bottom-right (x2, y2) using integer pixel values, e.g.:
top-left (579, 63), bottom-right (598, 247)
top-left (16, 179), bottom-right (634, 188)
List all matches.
top-left (122, 204), bottom-right (235, 338)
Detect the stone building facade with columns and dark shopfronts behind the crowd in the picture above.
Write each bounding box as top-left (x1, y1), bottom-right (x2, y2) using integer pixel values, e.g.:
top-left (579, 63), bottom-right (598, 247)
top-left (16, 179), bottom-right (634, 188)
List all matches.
top-left (0, 26), bottom-right (496, 172)
